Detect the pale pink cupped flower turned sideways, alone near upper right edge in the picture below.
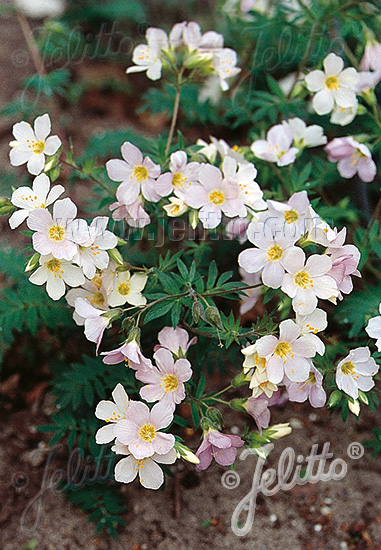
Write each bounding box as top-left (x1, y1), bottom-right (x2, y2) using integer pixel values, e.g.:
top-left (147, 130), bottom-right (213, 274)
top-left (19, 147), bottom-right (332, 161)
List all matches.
top-left (324, 137), bottom-right (377, 182)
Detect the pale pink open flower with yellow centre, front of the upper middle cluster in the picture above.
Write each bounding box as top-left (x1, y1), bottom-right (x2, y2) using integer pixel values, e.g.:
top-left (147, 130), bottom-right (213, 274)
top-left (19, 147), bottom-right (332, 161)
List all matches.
top-left (185, 164), bottom-right (246, 229)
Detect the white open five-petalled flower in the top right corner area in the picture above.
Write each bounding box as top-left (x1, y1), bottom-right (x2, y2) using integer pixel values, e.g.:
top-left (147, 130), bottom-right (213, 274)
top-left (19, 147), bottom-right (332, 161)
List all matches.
top-left (306, 53), bottom-right (359, 115)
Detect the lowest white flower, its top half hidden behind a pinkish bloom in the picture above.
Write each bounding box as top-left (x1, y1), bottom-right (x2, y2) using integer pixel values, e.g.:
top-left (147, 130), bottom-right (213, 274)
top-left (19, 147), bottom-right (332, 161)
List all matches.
top-left (111, 443), bottom-right (177, 489)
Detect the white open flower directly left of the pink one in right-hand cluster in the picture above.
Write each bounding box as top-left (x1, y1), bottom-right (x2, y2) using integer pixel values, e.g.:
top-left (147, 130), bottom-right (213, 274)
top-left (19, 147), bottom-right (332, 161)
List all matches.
top-left (281, 247), bottom-right (338, 315)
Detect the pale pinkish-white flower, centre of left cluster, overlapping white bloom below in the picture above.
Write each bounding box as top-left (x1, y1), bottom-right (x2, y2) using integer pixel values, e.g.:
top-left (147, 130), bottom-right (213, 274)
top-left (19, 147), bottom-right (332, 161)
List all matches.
top-left (27, 198), bottom-right (89, 260)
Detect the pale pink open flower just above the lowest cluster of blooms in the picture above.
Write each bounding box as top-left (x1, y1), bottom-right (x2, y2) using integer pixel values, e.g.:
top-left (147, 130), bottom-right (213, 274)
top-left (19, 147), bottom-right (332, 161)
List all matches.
top-left (136, 348), bottom-right (192, 407)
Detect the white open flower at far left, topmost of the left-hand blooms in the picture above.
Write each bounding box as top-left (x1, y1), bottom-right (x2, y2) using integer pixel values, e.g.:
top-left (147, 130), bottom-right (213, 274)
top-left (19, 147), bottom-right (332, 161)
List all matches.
top-left (9, 114), bottom-right (61, 175)
